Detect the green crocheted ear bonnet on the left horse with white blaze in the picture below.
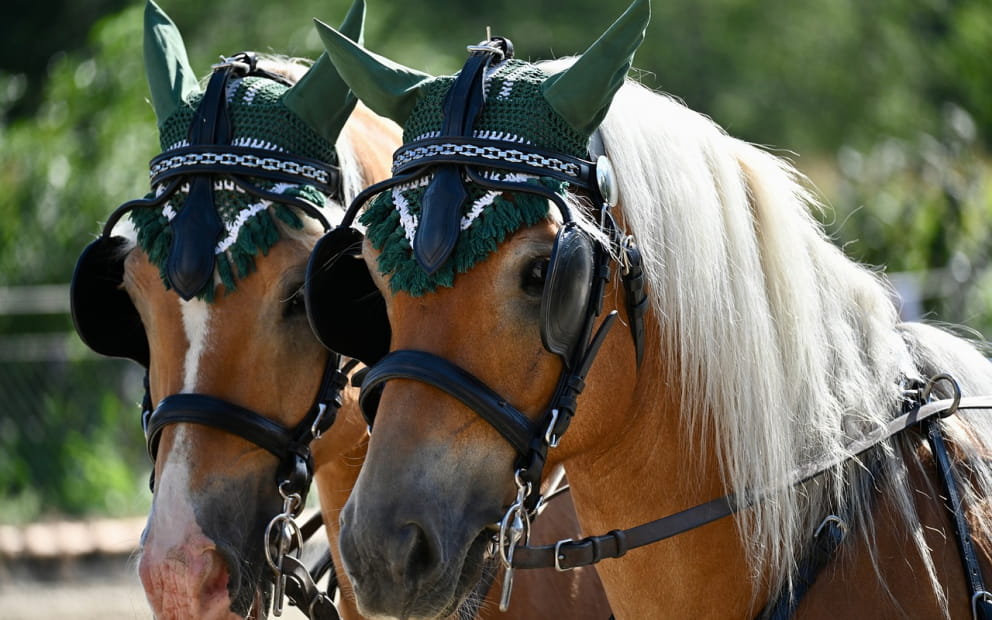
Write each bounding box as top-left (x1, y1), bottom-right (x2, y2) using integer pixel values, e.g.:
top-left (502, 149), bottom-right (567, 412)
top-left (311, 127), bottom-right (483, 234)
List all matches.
top-left (130, 0), bottom-right (364, 301)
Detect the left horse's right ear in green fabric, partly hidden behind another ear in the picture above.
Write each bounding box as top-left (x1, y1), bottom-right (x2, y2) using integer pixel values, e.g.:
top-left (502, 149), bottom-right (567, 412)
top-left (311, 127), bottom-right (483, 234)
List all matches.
top-left (282, 0), bottom-right (365, 142)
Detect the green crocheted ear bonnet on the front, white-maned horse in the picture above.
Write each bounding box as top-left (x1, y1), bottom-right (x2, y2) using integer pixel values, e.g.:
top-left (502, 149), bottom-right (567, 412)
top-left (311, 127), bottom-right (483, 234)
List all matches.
top-left (317, 0), bottom-right (650, 296)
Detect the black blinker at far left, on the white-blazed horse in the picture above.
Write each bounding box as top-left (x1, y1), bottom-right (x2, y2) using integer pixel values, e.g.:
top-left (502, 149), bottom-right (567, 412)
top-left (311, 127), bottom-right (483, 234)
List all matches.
top-left (69, 237), bottom-right (149, 368)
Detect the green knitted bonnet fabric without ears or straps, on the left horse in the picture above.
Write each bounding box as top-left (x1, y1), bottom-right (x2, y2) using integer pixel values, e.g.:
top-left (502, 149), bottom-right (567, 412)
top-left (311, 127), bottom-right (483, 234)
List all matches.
top-left (131, 77), bottom-right (337, 301)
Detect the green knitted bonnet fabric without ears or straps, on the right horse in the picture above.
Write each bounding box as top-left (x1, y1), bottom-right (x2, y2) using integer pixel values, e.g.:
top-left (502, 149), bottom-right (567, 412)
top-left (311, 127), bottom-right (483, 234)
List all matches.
top-left (360, 59), bottom-right (589, 296)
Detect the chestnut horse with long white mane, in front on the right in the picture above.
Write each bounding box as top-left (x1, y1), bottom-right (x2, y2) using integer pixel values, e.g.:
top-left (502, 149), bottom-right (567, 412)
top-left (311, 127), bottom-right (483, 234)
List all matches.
top-left (308, 0), bottom-right (992, 619)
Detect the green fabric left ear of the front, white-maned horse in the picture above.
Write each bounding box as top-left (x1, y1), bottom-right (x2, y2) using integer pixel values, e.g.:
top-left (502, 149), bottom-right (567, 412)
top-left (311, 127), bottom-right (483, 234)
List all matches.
top-left (314, 20), bottom-right (433, 125)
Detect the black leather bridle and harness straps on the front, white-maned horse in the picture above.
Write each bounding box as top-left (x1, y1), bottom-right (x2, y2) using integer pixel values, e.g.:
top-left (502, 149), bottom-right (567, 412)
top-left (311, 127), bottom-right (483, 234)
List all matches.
top-left (305, 38), bottom-right (992, 619)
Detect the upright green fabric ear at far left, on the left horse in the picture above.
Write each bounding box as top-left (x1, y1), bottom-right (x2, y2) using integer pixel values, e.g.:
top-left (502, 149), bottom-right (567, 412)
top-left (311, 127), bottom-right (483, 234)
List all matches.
top-left (144, 0), bottom-right (200, 125)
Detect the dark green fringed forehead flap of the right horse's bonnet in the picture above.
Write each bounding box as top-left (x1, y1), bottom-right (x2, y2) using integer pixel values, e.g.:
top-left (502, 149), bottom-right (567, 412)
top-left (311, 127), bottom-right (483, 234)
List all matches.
top-left (360, 177), bottom-right (567, 297)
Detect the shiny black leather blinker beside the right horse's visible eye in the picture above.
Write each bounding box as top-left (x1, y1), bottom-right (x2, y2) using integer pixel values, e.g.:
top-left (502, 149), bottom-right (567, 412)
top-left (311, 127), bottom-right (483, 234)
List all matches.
top-left (541, 222), bottom-right (595, 365)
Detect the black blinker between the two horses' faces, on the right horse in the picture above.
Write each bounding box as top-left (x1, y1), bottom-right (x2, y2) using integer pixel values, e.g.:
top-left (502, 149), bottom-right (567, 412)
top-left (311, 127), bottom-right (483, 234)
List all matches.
top-left (303, 227), bottom-right (391, 365)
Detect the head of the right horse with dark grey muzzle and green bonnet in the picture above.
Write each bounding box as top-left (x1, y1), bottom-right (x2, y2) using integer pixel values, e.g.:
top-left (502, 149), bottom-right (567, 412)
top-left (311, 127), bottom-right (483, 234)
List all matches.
top-left (309, 1), bottom-right (649, 618)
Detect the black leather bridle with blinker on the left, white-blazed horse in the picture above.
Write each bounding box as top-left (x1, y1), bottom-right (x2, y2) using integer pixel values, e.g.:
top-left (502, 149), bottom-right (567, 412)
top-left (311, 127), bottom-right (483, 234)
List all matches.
top-left (70, 52), bottom-right (344, 620)
